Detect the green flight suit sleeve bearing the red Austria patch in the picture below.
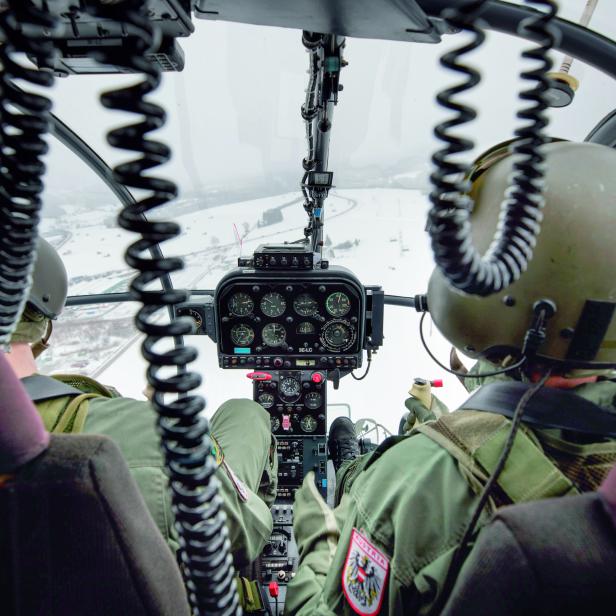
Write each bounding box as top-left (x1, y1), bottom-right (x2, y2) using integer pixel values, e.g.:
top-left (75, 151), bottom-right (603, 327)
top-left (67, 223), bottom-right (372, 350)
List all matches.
top-left (285, 434), bottom-right (484, 616)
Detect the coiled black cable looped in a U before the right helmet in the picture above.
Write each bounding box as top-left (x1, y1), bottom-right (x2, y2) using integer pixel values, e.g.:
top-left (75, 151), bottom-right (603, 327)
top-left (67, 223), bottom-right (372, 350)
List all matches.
top-left (429, 0), bottom-right (557, 296)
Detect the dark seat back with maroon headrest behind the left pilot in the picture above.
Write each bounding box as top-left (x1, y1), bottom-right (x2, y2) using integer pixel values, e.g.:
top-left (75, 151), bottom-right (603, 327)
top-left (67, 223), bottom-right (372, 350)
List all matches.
top-left (0, 353), bottom-right (189, 616)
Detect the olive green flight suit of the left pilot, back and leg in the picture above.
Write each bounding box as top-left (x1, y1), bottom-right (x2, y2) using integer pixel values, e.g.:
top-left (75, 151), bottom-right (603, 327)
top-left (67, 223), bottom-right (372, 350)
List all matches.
top-left (30, 375), bottom-right (277, 566)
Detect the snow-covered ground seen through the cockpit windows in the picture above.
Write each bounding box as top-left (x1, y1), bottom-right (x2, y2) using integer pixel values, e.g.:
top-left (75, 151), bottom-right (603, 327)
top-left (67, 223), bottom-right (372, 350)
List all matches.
top-left (38, 188), bottom-right (472, 431)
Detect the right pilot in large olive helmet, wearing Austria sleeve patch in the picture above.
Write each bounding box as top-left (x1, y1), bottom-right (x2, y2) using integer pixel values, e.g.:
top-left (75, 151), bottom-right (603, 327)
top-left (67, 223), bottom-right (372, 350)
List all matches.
top-left (285, 142), bottom-right (616, 616)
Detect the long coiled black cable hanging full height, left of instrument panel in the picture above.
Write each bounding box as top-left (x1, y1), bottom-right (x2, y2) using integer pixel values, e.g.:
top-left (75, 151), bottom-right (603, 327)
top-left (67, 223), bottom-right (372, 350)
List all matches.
top-left (85, 0), bottom-right (241, 616)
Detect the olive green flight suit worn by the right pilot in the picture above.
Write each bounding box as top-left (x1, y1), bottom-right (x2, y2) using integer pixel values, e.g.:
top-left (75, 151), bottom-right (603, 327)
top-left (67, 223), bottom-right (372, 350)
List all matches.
top-left (285, 372), bottom-right (616, 616)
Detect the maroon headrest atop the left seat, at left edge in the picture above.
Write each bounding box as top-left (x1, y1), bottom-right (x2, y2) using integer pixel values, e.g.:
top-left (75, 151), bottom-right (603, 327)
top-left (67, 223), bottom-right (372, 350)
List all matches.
top-left (0, 351), bottom-right (49, 473)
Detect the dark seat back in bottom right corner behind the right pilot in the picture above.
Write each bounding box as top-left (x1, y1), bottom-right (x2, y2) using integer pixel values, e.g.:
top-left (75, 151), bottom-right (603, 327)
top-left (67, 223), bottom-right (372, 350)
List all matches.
top-left (442, 467), bottom-right (616, 616)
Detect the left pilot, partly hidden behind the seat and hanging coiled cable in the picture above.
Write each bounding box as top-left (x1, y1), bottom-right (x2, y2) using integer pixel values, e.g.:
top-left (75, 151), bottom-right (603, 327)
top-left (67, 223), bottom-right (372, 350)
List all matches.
top-left (6, 238), bottom-right (277, 588)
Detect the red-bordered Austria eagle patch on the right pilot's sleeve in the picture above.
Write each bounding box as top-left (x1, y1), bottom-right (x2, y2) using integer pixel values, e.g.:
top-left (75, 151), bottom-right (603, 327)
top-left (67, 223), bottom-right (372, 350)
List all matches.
top-left (342, 528), bottom-right (389, 616)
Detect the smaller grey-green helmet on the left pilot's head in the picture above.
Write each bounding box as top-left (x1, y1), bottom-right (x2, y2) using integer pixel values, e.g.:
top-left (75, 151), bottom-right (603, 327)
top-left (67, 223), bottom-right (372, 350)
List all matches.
top-left (28, 237), bottom-right (68, 319)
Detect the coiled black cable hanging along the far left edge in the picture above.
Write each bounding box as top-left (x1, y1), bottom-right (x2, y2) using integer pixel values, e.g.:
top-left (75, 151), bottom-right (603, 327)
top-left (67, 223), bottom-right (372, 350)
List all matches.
top-left (0, 0), bottom-right (56, 345)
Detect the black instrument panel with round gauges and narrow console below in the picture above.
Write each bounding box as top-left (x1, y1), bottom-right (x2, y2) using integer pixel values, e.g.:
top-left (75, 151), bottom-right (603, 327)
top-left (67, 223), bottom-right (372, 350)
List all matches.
top-left (178, 245), bottom-right (384, 614)
